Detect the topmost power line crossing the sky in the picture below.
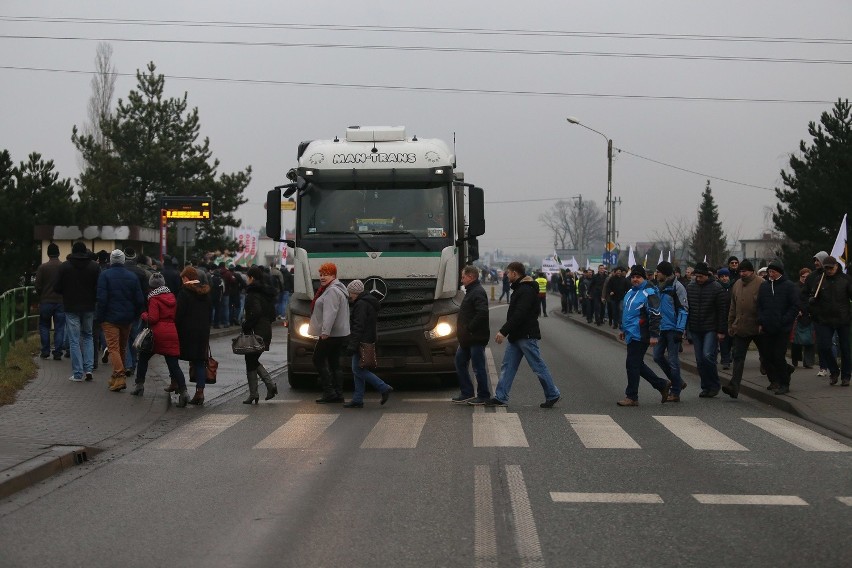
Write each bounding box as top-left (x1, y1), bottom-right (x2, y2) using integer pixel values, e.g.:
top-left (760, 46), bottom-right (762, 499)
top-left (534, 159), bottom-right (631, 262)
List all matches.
top-left (0, 16), bottom-right (852, 45)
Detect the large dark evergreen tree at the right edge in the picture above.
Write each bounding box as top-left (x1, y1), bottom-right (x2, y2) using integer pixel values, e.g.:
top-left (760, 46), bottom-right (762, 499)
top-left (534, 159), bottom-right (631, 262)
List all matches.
top-left (772, 99), bottom-right (852, 267)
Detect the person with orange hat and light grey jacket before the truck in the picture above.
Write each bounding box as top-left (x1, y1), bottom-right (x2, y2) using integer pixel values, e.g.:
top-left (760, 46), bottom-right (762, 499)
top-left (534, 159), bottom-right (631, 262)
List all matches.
top-left (308, 262), bottom-right (349, 404)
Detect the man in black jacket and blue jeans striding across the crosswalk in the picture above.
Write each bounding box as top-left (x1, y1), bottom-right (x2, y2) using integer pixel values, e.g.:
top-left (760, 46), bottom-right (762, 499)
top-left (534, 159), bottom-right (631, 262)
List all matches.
top-left (486, 262), bottom-right (561, 408)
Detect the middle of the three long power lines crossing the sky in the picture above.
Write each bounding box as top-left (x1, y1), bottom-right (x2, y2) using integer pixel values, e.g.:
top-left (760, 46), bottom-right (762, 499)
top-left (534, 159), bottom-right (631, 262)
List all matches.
top-left (0, 34), bottom-right (852, 65)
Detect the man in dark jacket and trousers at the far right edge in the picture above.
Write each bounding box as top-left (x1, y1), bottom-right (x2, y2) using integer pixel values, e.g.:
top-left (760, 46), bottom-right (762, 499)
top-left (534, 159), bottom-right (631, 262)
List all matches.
top-left (808, 256), bottom-right (852, 387)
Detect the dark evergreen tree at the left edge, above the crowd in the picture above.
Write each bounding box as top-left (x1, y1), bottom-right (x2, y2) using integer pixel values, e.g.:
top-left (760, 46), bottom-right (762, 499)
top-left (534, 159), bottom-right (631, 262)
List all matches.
top-left (0, 150), bottom-right (74, 290)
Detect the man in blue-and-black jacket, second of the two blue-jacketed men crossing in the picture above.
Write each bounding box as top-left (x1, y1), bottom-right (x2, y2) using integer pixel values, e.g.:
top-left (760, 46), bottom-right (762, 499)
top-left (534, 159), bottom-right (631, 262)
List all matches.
top-left (654, 260), bottom-right (689, 402)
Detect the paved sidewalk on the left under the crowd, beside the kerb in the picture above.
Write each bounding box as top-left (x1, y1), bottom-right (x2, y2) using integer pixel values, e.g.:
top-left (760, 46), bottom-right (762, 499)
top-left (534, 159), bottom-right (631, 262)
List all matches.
top-left (0, 325), bottom-right (287, 499)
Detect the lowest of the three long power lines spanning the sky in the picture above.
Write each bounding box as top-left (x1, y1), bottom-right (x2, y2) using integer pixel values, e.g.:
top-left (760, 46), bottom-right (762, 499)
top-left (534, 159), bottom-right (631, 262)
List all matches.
top-left (0, 65), bottom-right (834, 105)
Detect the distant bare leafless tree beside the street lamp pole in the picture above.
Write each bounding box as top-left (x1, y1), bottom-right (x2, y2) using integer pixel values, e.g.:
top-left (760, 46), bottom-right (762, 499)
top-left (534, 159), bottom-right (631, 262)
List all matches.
top-left (539, 196), bottom-right (606, 250)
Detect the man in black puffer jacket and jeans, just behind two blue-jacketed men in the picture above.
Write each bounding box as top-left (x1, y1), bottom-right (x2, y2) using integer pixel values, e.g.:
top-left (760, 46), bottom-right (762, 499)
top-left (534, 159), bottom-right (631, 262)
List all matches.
top-left (686, 262), bottom-right (728, 398)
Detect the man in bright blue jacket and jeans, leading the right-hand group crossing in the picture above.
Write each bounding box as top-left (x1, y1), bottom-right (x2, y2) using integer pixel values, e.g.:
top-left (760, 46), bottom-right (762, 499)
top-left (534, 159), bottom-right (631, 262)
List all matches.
top-left (616, 264), bottom-right (677, 406)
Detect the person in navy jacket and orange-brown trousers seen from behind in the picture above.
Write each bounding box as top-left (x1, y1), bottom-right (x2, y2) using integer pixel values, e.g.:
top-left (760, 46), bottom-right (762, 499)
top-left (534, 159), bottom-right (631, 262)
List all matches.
top-left (95, 249), bottom-right (145, 392)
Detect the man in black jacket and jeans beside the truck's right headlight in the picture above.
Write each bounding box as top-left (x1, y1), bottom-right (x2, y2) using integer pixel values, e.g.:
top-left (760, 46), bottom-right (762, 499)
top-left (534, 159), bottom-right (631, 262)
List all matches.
top-left (452, 266), bottom-right (491, 404)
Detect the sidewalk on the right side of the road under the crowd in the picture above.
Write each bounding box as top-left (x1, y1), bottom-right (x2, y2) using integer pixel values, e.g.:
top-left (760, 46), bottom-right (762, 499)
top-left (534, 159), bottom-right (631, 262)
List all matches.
top-left (549, 304), bottom-right (852, 438)
